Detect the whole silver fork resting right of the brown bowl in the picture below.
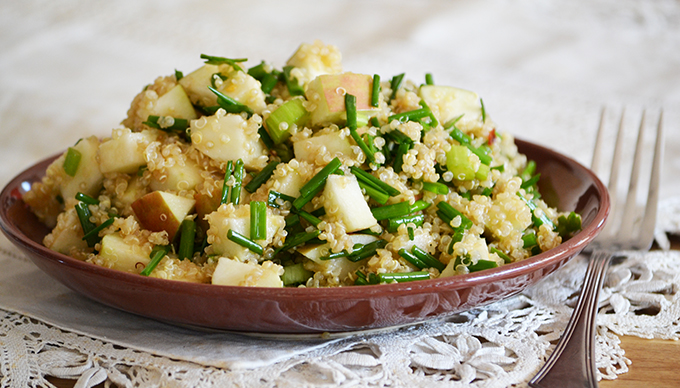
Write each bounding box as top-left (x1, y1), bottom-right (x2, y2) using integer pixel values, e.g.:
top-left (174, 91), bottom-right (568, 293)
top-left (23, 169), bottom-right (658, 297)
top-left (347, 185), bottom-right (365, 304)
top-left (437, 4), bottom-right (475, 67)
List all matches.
top-left (529, 109), bottom-right (663, 388)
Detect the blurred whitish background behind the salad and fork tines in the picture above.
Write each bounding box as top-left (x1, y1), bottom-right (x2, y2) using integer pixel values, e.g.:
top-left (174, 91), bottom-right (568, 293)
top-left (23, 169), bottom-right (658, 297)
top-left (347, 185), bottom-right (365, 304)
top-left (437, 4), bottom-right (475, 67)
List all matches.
top-left (0, 0), bottom-right (680, 197)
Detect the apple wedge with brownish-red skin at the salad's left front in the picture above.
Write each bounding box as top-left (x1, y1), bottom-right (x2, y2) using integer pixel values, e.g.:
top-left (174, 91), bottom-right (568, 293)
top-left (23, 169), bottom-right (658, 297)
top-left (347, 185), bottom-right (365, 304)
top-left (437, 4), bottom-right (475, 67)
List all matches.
top-left (132, 191), bottom-right (196, 241)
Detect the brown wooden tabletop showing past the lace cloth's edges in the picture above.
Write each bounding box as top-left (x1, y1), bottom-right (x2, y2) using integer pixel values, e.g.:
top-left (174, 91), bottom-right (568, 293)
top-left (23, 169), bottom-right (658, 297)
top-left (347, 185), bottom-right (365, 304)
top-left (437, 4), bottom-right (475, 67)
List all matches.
top-left (48, 237), bottom-right (680, 388)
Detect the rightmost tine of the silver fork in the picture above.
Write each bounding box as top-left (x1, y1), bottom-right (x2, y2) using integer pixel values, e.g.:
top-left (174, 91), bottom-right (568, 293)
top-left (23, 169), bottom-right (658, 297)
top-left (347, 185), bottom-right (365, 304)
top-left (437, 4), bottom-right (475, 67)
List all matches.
top-left (637, 109), bottom-right (663, 249)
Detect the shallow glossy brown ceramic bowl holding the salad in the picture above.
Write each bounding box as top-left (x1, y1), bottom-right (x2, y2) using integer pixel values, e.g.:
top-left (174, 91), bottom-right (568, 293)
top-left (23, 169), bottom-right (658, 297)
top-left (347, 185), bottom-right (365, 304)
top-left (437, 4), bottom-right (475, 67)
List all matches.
top-left (0, 140), bottom-right (609, 334)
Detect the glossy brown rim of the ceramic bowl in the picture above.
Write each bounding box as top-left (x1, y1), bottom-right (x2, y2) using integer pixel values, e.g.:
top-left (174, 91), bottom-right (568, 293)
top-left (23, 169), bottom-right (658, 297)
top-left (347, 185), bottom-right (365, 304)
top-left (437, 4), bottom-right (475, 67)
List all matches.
top-left (0, 138), bottom-right (610, 301)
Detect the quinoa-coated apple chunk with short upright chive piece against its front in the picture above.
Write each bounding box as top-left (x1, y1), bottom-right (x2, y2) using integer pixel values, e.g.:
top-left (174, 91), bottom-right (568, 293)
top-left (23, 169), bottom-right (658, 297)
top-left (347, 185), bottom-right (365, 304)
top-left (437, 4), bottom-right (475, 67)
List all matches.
top-left (206, 204), bottom-right (286, 261)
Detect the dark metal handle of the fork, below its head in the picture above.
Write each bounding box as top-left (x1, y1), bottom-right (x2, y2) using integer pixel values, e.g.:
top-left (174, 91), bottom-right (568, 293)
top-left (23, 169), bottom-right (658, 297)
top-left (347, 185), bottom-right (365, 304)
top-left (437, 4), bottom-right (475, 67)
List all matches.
top-left (529, 251), bottom-right (612, 388)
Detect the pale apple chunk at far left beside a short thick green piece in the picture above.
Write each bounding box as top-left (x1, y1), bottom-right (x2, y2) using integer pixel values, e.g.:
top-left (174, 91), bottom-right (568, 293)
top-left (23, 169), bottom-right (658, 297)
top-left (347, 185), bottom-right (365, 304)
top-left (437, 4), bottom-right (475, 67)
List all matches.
top-left (60, 136), bottom-right (104, 200)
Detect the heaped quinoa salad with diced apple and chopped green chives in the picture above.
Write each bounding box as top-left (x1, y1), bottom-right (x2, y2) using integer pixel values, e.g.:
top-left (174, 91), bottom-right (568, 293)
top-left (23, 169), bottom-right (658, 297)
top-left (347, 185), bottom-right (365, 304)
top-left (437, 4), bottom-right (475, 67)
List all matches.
top-left (24, 41), bottom-right (581, 287)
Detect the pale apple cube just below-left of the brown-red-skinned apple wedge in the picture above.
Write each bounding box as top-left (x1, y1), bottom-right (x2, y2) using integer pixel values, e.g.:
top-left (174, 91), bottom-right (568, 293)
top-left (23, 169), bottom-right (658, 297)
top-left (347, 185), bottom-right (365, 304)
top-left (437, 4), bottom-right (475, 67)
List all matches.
top-left (99, 233), bottom-right (150, 273)
